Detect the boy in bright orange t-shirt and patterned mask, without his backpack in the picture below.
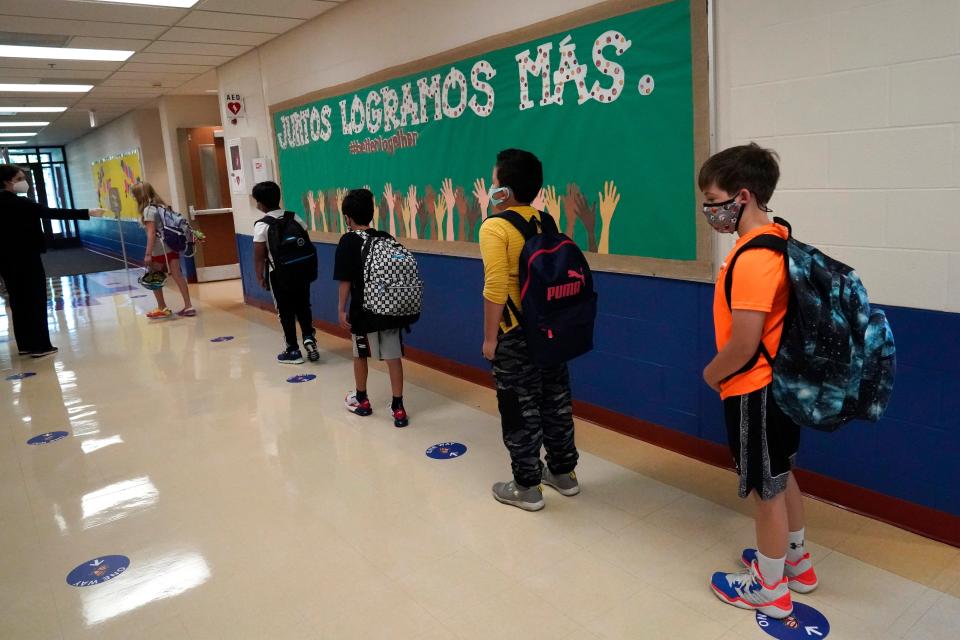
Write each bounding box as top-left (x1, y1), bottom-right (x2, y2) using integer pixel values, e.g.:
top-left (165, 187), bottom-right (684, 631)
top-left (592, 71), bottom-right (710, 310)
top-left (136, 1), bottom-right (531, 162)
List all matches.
top-left (699, 143), bottom-right (817, 618)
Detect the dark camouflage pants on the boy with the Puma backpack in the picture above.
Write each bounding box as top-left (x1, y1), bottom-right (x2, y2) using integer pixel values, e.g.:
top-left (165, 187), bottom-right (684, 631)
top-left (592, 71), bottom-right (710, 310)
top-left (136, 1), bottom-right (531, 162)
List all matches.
top-left (493, 329), bottom-right (579, 487)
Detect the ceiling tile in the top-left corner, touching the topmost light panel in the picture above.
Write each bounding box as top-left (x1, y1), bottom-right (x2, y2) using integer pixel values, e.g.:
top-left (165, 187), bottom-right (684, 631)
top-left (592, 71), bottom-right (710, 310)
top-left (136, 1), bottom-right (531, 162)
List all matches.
top-left (3, 0), bottom-right (188, 26)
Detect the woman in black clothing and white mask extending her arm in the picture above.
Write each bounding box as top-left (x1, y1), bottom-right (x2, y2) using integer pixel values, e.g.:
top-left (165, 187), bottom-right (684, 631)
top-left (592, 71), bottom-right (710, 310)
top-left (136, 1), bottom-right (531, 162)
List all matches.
top-left (0, 164), bottom-right (104, 358)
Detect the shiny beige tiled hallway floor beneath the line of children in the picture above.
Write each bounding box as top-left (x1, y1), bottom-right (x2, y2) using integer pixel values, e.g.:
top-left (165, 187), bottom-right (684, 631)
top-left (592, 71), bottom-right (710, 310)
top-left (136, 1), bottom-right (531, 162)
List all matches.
top-left (0, 272), bottom-right (960, 640)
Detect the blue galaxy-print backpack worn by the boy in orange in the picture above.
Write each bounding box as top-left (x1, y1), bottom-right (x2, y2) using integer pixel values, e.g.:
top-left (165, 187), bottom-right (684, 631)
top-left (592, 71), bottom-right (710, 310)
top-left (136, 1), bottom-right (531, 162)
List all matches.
top-left (724, 218), bottom-right (897, 431)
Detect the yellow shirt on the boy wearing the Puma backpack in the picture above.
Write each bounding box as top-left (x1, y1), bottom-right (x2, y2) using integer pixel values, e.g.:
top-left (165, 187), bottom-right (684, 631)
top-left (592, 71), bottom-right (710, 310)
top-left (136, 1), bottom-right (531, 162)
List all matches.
top-left (480, 207), bottom-right (540, 333)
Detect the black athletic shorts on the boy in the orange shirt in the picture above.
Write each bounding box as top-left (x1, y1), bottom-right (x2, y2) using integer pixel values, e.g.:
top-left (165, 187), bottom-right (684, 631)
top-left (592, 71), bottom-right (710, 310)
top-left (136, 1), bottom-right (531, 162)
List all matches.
top-left (723, 385), bottom-right (800, 500)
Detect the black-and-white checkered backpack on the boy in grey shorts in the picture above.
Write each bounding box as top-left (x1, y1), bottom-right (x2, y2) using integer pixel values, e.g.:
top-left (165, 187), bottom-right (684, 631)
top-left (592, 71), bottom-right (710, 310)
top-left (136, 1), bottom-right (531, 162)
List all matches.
top-left (356, 231), bottom-right (423, 331)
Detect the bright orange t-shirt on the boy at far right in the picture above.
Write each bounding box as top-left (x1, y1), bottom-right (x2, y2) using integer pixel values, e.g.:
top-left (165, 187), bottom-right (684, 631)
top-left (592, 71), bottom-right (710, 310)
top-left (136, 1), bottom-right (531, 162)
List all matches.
top-left (713, 224), bottom-right (790, 399)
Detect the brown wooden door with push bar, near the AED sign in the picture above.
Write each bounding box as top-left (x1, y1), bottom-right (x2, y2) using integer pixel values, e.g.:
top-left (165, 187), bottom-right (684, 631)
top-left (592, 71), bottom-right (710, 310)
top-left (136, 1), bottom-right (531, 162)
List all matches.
top-left (177, 127), bottom-right (240, 282)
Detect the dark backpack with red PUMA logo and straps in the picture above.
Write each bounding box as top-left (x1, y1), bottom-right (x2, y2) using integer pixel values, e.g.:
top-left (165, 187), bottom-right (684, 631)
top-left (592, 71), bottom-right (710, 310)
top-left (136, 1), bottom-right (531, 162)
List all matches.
top-left (488, 211), bottom-right (597, 368)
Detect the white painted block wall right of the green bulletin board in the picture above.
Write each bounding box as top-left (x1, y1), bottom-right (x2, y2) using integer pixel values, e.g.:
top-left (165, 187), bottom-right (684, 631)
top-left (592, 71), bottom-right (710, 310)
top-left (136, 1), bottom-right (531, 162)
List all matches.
top-left (715, 0), bottom-right (960, 312)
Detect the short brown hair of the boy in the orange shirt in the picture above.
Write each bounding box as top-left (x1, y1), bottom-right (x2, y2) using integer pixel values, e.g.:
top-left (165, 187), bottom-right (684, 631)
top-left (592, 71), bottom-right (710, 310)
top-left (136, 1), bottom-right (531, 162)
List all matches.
top-left (697, 142), bottom-right (780, 207)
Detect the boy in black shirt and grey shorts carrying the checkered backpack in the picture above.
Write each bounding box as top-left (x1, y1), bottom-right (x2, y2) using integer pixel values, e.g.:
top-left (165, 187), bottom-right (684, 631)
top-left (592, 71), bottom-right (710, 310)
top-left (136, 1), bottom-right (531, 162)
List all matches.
top-left (333, 189), bottom-right (410, 427)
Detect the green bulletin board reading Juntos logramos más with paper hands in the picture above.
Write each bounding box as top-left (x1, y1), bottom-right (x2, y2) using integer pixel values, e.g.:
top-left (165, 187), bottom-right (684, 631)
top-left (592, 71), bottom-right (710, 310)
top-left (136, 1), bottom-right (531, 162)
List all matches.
top-left (273, 0), bottom-right (709, 272)
